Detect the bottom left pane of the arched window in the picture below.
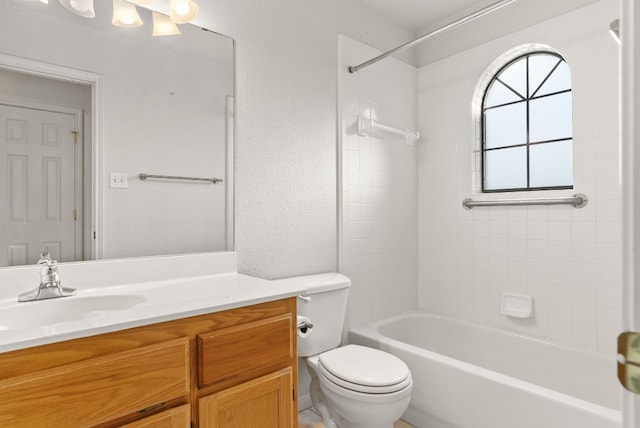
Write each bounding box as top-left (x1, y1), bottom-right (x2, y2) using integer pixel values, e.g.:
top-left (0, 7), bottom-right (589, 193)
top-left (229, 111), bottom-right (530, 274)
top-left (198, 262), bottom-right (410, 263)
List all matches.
top-left (484, 147), bottom-right (527, 190)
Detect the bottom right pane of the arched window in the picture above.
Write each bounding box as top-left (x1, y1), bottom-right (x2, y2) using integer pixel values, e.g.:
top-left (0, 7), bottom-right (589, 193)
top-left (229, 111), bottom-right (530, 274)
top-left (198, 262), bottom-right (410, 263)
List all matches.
top-left (529, 140), bottom-right (573, 187)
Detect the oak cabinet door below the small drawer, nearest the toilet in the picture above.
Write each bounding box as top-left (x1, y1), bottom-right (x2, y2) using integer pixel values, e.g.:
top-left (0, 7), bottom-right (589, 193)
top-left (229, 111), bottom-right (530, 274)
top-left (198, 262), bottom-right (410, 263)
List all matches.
top-left (199, 367), bottom-right (294, 428)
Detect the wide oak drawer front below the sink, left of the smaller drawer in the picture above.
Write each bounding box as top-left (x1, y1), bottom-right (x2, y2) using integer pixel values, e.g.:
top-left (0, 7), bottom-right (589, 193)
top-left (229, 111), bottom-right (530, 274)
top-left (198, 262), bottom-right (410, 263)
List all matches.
top-left (0, 338), bottom-right (189, 428)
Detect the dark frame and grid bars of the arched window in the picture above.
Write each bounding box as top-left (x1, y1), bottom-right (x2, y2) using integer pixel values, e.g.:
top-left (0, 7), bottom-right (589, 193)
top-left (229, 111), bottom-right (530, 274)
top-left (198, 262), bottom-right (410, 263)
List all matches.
top-left (480, 49), bottom-right (574, 193)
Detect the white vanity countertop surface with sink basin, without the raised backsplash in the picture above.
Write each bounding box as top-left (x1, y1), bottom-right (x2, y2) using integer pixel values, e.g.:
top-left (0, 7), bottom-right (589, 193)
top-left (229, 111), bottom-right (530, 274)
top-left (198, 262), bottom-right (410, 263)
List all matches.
top-left (0, 273), bottom-right (305, 352)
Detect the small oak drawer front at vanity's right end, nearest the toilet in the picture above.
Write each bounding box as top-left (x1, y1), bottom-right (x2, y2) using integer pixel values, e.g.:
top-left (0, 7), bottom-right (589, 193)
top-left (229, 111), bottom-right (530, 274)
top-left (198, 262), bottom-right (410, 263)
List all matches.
top-left (198, 313), bottom-right (295, 387)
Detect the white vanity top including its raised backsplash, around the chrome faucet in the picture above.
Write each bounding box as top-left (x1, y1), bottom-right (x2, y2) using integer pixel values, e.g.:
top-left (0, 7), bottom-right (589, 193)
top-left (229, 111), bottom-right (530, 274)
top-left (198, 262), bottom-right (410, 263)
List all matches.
top-left (0, 253), bottom-right (304, 352)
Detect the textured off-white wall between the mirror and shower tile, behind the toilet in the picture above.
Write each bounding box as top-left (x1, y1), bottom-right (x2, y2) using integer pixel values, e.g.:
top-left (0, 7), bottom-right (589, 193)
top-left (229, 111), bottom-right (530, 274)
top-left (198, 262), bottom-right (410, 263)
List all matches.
top-left (198, 0), bottom-right (414, 278)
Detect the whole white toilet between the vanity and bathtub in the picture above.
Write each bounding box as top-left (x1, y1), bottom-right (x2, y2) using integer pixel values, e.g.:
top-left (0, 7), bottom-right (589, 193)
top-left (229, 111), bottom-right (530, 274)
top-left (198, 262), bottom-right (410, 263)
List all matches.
top-left (281, 273), bottom-right (413, 428)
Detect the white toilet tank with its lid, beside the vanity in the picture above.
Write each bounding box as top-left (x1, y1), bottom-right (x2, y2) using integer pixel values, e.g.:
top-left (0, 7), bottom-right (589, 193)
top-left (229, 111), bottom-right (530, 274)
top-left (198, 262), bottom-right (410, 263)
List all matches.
top-left (278, 273), bottom-right (351, 357)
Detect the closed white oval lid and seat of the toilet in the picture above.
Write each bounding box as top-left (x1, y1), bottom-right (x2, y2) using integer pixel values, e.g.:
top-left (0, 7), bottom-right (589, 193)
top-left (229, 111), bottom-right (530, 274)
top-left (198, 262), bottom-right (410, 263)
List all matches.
top-left (319, 345), bottom-right (411, 394)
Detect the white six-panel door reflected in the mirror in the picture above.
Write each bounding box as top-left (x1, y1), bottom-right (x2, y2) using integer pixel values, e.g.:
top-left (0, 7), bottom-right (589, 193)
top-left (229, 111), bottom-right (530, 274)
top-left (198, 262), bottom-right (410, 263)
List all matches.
top-left (0, 104), bottom-right (80, 266)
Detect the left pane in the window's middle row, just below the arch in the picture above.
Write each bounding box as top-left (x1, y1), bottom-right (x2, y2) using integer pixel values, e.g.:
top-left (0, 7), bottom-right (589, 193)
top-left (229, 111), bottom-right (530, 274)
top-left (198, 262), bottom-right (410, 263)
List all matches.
top-left (484, 102), bottom-right (527, 149)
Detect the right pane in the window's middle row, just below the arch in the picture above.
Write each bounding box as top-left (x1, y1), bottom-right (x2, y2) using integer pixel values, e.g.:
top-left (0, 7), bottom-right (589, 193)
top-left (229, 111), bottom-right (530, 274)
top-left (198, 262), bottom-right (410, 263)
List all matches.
top-left (529, 92), bottom-right (572, 143)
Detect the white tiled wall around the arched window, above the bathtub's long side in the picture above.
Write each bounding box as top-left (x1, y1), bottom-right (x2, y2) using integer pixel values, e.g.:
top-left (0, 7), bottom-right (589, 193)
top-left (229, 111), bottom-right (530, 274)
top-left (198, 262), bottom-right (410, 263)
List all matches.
top-left (418, 0), bottom-right (622, 353)
